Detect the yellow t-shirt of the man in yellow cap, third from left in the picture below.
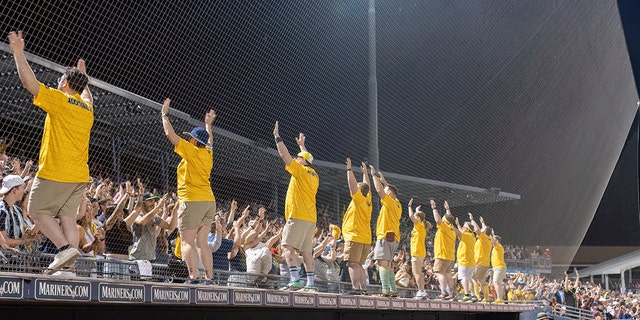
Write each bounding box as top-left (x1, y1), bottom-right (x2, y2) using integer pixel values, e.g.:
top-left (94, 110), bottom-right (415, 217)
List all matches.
top-left (284, 160), bottom-right (320, 222)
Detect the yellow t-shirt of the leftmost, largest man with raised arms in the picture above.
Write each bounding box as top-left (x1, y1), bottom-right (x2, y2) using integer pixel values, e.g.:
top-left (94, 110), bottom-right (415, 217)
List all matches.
top-left (33, 83), bottom-right (93, 183)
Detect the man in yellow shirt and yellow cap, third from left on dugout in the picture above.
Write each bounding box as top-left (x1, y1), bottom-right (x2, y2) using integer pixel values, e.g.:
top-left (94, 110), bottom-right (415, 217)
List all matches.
top-left (273, 121), bottom-right (320, 292)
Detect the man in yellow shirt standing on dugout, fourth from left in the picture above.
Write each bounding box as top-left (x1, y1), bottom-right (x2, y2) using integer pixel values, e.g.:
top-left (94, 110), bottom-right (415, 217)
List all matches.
top-left (342, 158), bottom-right (373, 295)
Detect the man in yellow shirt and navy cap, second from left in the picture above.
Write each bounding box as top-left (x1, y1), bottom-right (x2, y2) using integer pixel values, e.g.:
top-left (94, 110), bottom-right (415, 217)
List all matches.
top-left (162, 99), bottom-right (216, 284)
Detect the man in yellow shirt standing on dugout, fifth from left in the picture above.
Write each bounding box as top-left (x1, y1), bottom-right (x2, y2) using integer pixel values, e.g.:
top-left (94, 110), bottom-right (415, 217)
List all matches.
top-left (370, 166), bottom-right (402, 297)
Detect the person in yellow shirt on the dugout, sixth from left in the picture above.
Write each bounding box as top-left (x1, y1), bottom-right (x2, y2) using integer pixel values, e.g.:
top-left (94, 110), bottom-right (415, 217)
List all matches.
top-left (408, 198), bottom-right (431, 299)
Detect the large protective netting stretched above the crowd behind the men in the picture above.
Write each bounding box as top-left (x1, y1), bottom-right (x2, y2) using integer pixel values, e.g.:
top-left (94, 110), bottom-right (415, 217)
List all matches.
top-left (0, 0), bottom-right (638, 278)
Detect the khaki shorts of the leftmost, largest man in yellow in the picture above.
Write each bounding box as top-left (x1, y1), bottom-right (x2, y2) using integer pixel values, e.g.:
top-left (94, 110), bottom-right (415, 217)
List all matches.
top-left (28, 177), bottom-right (87, 220)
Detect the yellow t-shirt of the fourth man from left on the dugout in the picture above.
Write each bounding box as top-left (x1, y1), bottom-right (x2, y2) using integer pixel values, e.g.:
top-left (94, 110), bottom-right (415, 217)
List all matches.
top-left (342, 189), bottom-right (373, 244)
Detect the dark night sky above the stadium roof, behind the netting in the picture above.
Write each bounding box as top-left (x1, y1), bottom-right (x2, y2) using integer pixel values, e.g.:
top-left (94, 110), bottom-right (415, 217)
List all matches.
top-left (0, 0), bottom-right (640, 262)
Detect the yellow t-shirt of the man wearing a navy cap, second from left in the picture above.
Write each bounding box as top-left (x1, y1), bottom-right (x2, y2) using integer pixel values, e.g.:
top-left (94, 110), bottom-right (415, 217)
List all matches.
top-left (173, 138), bottom-right (216, 202)
